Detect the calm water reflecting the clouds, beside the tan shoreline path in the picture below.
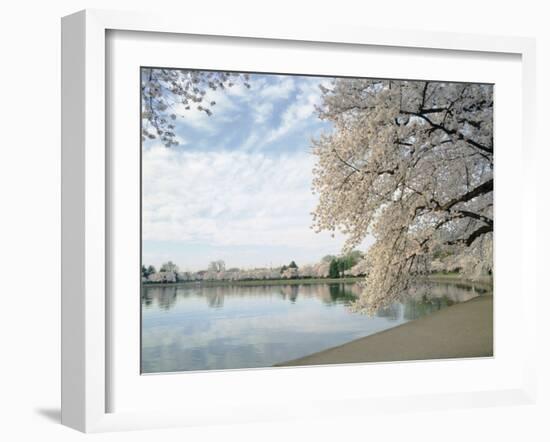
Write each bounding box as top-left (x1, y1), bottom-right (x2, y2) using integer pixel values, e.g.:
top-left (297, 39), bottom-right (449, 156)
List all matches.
top-left (141, 282), bottom-right (488, 373)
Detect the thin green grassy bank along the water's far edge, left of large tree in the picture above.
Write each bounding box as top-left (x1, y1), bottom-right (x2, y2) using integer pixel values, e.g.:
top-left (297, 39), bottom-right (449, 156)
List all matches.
top-left (142, 276), bottom-right (364, 287)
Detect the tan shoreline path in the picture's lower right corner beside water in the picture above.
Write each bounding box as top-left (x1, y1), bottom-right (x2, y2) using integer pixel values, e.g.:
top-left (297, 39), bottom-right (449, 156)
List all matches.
top-left (276, 295), bottom-right (493, 366)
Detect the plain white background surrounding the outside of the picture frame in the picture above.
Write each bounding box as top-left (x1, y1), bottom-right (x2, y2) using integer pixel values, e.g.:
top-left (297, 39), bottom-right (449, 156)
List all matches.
top-left (0, 0), bottom-right (550, 441)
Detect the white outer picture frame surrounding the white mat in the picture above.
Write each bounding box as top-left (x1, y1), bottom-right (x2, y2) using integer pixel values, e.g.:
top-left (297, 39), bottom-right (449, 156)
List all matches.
top-left (62, 10), bottom-right (537, 432)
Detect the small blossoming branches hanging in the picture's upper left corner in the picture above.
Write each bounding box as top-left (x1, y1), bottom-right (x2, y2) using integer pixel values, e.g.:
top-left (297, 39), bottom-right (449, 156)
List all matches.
top-left (141, 68), bottom-right (250, 147)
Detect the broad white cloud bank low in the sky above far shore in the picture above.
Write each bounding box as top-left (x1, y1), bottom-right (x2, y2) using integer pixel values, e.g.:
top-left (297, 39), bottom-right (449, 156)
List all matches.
top-left (143, 146), bottom-right (348, 252)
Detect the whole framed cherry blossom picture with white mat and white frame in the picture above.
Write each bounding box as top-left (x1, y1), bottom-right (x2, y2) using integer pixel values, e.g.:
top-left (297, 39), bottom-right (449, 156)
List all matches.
top-left (62, 11), bottom-right (536, 432)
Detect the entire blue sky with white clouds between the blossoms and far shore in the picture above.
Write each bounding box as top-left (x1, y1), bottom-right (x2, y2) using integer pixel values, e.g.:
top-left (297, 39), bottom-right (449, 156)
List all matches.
top-left (142, 74), bottom-right (358, 271)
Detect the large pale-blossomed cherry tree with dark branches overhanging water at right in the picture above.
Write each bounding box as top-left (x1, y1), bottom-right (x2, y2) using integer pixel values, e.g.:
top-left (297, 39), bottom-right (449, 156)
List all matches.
top-left (313, 79), bottom-right (493, 313)
